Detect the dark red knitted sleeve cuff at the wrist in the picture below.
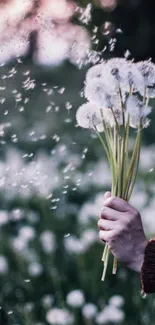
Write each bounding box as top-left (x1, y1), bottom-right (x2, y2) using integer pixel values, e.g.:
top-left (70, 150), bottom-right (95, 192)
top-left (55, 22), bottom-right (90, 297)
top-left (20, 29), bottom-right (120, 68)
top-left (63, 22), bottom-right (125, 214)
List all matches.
top-left (141, 238), bottom-right (155, 294)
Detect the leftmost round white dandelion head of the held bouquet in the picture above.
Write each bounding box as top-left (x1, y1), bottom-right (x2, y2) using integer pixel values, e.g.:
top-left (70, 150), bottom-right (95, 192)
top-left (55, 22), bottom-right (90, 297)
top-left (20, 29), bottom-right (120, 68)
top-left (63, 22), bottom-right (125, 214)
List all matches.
top-left (76, 102), bottom-right (103, 132)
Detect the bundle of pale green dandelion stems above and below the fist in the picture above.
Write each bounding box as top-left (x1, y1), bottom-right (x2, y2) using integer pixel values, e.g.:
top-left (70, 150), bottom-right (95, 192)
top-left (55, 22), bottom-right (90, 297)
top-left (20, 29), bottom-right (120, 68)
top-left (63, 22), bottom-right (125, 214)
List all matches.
top-left (96, 93), bottom-right (142, 281)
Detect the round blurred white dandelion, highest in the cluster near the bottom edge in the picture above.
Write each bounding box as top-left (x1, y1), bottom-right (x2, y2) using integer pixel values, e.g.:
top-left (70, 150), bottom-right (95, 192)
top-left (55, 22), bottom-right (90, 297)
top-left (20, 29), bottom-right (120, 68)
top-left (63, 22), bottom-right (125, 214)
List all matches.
top-left (66, 290), bottom-right (85, 308)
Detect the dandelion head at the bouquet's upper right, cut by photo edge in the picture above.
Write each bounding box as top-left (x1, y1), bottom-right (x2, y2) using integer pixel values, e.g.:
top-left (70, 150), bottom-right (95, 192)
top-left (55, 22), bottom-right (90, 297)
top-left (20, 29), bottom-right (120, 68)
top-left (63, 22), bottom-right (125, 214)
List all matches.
top-left (137, 60), bottom-right (155, 98)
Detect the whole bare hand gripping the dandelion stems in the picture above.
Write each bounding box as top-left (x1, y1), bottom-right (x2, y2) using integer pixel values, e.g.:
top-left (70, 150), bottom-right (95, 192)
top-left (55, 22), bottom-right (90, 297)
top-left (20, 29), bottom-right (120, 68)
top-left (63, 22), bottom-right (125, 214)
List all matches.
top-left (98, 192), bottom-right (148, 272)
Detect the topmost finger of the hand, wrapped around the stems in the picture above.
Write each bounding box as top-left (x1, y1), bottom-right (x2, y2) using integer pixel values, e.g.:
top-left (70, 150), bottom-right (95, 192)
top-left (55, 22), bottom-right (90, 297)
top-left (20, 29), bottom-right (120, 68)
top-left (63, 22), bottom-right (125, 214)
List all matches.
top-left (104, 196), bottom-right (131, 212)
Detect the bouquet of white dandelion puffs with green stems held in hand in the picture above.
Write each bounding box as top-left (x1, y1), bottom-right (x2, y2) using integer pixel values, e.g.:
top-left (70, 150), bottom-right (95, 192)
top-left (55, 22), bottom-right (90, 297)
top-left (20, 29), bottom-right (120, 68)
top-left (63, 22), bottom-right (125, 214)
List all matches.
top-left (76, 58), bottom-right (155, 281)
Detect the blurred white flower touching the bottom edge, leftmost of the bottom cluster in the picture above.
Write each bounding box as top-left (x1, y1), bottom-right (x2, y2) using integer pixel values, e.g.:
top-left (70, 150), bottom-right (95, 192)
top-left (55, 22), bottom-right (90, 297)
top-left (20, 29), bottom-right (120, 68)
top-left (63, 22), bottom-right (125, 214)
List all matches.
top-left (46, 308), bottom-right (74, 325)
